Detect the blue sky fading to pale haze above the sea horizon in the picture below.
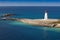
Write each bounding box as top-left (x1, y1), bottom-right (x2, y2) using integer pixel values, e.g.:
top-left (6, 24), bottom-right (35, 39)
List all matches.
top-left (0, 0), bottom-right (60, 6)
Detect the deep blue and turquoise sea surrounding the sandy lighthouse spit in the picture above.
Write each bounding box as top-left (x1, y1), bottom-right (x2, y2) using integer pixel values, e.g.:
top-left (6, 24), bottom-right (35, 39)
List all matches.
top-left (0, 6), bottom-right (60, 40)
